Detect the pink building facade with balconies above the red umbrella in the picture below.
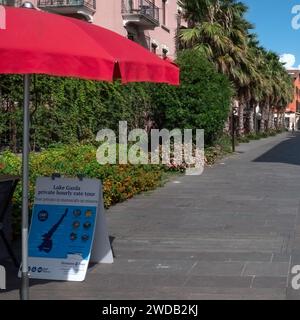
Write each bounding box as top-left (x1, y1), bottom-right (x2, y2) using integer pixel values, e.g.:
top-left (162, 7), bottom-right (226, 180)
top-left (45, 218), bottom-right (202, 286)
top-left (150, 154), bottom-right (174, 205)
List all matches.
top-left (5, 0), bottom-right (182, 59)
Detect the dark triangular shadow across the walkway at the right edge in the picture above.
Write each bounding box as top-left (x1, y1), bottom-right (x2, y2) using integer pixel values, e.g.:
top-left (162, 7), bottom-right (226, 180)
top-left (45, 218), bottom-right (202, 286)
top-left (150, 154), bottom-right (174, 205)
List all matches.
top-left (253, 132), bottom-right (300, 165)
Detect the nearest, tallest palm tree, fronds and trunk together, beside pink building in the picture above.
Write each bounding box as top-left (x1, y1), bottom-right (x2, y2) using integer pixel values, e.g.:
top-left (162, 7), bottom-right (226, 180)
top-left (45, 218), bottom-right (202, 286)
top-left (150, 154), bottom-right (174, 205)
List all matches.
top-left (179, 0), bottom-right (255, 135)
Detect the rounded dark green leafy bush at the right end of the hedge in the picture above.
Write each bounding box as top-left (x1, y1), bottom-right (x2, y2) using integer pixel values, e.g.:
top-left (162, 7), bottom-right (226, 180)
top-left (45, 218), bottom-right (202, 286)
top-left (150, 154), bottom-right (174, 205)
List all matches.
top-left (152, 50), bottom-right (232, 145)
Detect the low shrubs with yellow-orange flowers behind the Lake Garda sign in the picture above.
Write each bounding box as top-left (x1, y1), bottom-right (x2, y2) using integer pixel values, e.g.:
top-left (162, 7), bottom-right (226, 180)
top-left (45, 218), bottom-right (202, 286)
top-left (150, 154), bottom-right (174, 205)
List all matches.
top-left (0, 145), bottom-right (167, 233)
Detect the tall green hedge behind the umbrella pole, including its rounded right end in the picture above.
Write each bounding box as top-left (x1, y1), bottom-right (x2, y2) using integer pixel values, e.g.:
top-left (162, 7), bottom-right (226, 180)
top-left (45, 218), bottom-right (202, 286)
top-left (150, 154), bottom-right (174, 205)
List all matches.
top-left (0, 50), bottom-right (232, 152)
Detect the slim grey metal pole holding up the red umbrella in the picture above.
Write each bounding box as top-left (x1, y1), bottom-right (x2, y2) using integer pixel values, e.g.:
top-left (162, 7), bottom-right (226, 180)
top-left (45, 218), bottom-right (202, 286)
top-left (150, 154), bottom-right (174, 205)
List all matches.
top-left (20, 74), bottom-right (30, 300)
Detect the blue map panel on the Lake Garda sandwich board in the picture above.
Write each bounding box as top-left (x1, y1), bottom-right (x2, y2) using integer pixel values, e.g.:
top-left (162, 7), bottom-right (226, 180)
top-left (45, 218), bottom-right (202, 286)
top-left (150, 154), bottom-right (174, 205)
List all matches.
top-left (29, 205), bottom-right (96, 259)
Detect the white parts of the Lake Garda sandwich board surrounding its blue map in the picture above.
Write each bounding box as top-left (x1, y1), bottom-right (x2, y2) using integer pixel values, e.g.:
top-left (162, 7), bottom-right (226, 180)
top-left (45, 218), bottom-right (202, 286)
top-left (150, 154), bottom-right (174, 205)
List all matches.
top-left (20, 177), bottom-right (113, 281)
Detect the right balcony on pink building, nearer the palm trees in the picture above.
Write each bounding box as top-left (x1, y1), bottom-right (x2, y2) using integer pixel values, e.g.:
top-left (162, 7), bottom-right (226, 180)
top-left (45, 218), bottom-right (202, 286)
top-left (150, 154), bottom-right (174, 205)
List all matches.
top-left (122, 0), bottom-right (159, 29)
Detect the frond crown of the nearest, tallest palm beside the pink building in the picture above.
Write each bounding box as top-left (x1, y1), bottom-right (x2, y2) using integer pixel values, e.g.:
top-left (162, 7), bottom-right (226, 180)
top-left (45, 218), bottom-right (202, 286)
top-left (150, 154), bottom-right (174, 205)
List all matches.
top-left (179, 0), bottom-right (251, 77)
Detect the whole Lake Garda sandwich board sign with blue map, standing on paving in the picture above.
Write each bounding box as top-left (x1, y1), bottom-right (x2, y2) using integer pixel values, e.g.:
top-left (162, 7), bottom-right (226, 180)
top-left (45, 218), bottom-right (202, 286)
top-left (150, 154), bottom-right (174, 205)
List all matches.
top-left (23, 178), bottom-right (113, 281)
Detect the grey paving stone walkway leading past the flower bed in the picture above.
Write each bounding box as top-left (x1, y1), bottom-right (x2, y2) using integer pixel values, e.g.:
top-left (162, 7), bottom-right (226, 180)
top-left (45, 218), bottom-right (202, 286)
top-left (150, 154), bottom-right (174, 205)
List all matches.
top-left (0, 133), bottom-right (300, 300)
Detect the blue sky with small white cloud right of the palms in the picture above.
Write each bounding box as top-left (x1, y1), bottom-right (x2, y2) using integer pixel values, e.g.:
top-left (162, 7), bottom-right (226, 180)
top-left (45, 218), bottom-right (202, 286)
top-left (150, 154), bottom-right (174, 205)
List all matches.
top-left (242, 0), bottom-right (300, 68)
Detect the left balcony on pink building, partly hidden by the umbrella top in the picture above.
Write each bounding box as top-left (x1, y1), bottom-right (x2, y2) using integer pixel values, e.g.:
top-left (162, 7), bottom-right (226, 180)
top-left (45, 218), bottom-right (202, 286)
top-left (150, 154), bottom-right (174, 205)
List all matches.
top-left (38, 0), bottom-right (96, 20)
